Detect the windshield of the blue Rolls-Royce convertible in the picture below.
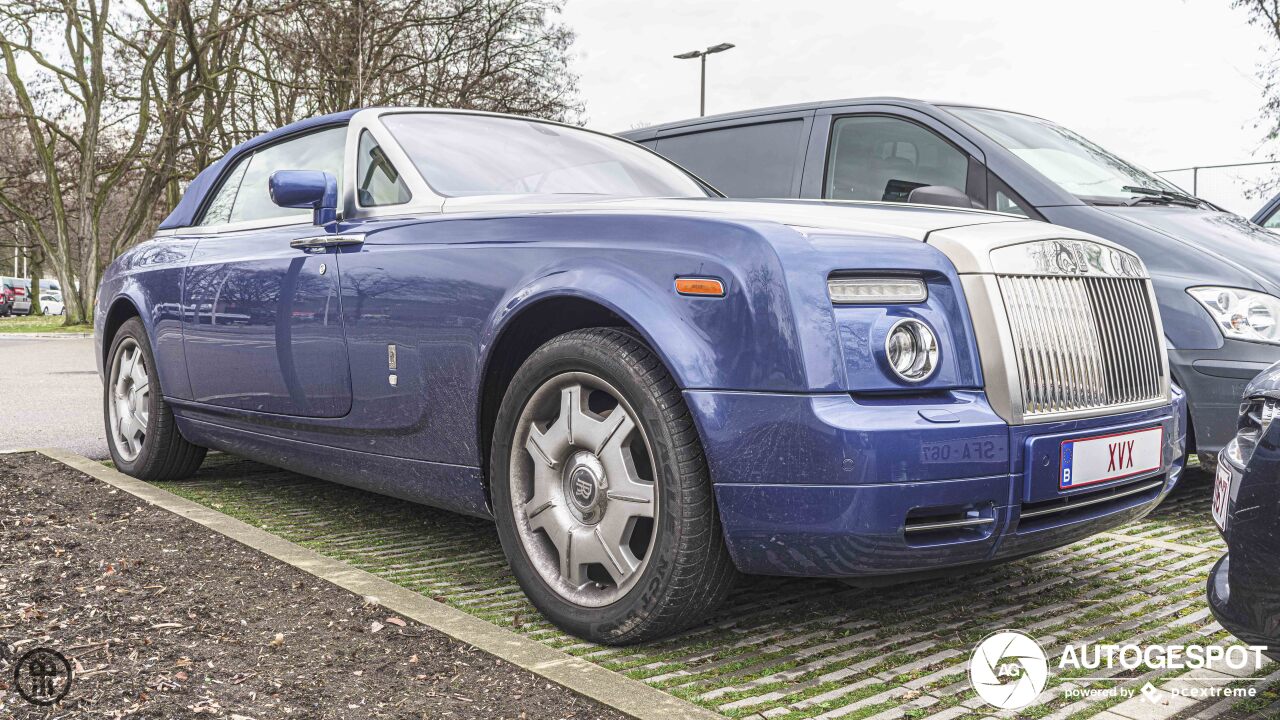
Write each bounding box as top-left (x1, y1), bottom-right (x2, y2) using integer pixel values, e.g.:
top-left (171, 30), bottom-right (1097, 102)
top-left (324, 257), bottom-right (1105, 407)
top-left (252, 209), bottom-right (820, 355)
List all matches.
top-left (383, 113), bottom-right (708, 197)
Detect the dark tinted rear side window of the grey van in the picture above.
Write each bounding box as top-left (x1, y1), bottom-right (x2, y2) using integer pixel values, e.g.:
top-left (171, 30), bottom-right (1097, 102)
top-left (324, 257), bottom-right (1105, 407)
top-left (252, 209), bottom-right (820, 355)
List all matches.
top-left (657, 119), bottom-right (804, 197)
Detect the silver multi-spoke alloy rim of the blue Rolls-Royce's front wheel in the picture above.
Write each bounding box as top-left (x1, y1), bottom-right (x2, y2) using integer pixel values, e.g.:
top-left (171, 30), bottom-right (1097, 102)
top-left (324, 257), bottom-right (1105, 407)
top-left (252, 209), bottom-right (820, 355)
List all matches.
top-left (509, 373), bottom-right (658, 607)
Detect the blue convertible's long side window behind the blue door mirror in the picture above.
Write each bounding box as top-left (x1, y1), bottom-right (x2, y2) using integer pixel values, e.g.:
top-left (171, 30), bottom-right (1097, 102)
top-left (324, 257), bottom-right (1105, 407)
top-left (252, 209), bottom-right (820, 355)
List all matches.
top-left (200, 127), bottom-right (347, 225)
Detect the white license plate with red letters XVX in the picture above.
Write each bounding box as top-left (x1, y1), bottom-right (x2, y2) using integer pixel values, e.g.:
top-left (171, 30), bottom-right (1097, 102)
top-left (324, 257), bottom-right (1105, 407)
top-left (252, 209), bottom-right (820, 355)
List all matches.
top-left (1059, 427), bottom-right (1165, 489)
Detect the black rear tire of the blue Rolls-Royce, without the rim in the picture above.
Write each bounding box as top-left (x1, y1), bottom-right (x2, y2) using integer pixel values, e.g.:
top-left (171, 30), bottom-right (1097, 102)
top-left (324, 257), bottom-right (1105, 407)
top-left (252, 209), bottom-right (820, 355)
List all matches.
top-left (102, 318), bottom-right (207, 480)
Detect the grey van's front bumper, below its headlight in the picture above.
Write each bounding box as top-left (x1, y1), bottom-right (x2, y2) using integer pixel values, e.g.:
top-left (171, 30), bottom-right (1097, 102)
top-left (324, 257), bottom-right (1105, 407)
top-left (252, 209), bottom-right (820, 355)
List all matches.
top-left (1169, 340), bottom-right (1280, 452)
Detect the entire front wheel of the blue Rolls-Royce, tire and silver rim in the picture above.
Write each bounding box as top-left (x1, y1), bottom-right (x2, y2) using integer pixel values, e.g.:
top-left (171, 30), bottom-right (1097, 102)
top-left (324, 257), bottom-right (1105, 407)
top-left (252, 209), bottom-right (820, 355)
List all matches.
top-left (490, 328), bottom-right (736, 644)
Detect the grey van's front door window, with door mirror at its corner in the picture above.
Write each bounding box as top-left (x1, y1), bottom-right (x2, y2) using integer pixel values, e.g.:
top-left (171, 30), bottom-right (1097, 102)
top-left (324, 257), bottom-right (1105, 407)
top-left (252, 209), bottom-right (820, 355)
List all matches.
top-left (823, 115), bottom-right (969, 202)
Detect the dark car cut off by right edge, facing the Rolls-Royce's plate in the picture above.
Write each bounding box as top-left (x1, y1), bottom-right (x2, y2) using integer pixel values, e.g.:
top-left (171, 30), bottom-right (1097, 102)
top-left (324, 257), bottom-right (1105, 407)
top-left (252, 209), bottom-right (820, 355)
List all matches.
top-left (1208, 365), bottom-right (1280, 660)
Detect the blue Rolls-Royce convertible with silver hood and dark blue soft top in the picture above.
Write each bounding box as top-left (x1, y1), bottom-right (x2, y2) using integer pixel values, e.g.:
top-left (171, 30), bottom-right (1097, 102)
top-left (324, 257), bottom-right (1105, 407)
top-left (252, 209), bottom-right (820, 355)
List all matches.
top-left (95, 109), bottom-right (1185, 643)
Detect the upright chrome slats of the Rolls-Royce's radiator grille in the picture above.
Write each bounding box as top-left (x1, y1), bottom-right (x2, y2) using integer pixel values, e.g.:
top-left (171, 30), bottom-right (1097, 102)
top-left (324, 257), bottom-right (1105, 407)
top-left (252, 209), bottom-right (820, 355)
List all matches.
top-left (997, 274), bottom-right (1165, 416)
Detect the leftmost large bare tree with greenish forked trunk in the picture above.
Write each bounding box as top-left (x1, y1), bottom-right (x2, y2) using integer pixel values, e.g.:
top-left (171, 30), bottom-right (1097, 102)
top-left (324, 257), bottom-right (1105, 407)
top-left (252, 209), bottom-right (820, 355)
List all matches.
top-left (0, 0), bottom-right (257, 323)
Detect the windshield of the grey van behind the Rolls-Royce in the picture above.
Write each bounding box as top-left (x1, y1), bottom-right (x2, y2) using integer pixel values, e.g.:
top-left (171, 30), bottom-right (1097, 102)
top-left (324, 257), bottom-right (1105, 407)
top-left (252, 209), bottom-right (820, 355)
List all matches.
top-left (947, 108), bottom-right (1183, 202)
